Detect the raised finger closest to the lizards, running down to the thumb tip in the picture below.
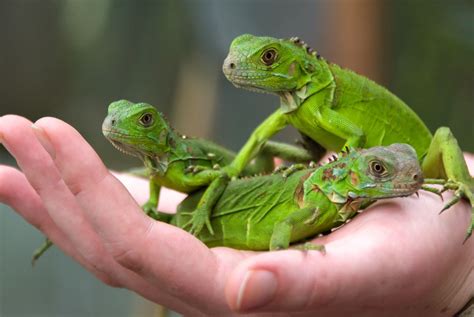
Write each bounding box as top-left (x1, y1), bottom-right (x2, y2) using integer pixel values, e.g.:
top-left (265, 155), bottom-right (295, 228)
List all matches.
top-left (32, 118), bottom-right (231, 309)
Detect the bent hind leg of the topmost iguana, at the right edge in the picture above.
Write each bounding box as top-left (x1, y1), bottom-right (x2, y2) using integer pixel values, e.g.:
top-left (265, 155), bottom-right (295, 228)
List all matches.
top-left (422, 127), bottom-right (474, 239)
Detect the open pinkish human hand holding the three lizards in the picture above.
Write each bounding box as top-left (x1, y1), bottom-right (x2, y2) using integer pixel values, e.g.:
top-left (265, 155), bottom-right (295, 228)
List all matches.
top-left (0, 115), bottom-right (474, 316)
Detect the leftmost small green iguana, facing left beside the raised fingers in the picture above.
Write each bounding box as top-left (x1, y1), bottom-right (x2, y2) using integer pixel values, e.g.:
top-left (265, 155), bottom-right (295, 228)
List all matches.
top-left (33, 100), bottom-right (312, 263)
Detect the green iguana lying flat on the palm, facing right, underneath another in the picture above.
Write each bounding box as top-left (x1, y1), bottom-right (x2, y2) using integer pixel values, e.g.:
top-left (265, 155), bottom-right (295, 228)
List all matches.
top-left (162, 144), bottom-right (423, 250)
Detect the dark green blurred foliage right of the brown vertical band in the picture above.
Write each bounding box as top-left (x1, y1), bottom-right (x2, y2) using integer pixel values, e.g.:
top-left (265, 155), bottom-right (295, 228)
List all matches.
top-left (386, 1), bottom-right (474, 152)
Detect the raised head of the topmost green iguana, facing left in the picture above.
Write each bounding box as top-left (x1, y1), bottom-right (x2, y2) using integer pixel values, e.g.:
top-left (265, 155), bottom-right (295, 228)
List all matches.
top-left (222, 34), bottom-right (319, 95)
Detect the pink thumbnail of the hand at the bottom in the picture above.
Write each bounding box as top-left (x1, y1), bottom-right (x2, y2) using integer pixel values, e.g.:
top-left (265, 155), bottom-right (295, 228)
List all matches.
top-left (237, 270), bottom-right (277, 311)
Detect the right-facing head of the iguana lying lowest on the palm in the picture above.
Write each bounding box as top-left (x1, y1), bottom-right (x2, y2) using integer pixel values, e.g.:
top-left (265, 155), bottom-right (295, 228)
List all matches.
top-left (312, 144), bottom-right (423, 203)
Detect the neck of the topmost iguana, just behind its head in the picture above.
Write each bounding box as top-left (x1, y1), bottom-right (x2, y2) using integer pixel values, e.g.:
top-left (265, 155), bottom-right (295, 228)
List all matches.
top-left (277, 59), bottom-right (335, 113)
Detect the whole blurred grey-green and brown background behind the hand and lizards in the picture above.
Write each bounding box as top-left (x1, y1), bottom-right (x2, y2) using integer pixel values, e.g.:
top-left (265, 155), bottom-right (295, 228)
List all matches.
top-left (0, 0), bottom-right (474, 317)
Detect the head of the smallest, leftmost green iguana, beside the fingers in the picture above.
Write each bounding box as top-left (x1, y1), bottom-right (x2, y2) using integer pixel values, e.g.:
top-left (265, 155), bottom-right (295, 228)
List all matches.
top-left (102, 100), bottom-right (171, 159)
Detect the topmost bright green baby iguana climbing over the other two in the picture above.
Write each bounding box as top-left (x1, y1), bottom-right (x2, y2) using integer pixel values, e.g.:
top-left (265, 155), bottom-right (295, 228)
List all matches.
top-left (223, 34), bottom-right (474, 239)
